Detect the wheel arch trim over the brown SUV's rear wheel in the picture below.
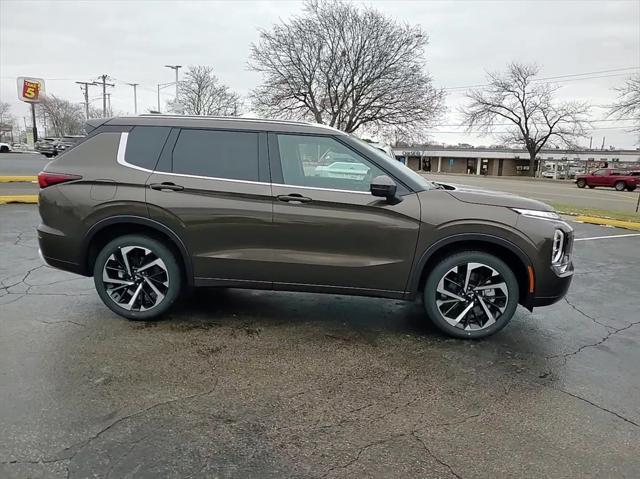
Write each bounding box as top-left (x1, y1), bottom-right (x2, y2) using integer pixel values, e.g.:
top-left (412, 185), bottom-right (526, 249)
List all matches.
top-left (82, 215), bottom-right (194, 287)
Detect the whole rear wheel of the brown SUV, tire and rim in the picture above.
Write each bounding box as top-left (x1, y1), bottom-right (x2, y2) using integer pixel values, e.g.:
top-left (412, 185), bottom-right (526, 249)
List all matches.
top-left (93, 235), bottom-right (182, 321)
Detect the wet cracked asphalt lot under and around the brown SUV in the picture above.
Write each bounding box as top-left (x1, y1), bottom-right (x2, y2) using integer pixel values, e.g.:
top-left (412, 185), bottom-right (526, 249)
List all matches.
top-left (0, 205), bottom-right (640, 479)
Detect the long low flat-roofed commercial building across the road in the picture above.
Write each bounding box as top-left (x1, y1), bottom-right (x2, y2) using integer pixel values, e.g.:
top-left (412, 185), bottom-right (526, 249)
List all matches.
top-left (393, 145), bottom-right (640, 176)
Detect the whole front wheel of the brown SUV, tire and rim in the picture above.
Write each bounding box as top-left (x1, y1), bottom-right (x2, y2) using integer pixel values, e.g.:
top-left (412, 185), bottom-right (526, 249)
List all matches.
top-left (424, 251), bottom-right (518, 338)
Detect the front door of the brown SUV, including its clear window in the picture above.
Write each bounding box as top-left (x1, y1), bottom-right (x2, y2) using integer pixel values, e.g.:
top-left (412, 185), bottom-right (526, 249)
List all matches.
top-left (269, 133), bottom-right (420, 294)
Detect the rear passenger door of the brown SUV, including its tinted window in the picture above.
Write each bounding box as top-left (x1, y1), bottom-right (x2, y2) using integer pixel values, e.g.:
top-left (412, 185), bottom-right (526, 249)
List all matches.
top-left (147, 128), bottom-right (272, 287)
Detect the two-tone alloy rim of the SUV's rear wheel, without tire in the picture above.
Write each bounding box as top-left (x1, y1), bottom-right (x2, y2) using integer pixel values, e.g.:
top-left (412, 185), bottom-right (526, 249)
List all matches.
top-left (102, 246), bottom-right (169, 311)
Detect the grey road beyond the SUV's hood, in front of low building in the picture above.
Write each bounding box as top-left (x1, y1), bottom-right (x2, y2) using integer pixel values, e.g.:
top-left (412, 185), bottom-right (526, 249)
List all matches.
top-left (424, 173), bottom-right (640, 212)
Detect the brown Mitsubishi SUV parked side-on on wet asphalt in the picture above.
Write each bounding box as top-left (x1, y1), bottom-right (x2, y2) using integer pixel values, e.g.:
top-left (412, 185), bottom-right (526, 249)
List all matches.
top-left (38, 115), bottom-right (573, 338)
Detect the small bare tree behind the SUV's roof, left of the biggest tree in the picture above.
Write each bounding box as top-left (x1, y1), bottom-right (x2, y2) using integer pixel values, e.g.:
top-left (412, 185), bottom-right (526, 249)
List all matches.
top-left (168, 65), bottom-right (241, 116)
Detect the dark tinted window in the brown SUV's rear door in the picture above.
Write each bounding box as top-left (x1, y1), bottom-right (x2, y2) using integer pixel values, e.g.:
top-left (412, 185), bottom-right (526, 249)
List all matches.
top-left (173, 129), bottom-right (258, 181)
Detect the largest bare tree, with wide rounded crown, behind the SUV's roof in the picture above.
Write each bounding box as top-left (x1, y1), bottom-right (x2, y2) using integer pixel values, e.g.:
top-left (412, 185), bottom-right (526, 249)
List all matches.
top-left (249, 0), bottom-right (444, 137)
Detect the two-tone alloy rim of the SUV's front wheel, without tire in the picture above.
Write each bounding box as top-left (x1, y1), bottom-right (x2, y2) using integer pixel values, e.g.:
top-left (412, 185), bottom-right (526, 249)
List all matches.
top-left (436, 263), bottom-right (509, 331)
